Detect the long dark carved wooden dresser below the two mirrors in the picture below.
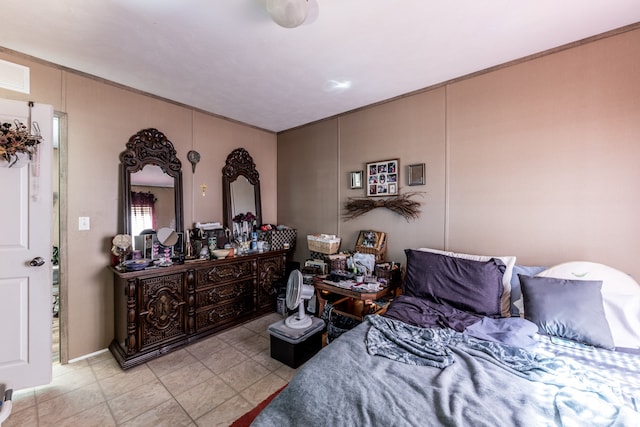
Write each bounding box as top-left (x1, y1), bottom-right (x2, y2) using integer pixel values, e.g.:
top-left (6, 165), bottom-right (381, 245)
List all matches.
top-left (109, 250), bottom-right (288, 369)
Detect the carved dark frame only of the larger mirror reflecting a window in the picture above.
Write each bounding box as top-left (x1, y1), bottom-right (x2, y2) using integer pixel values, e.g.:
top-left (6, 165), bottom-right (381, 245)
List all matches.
top-left (120, 128), bottom-right (183, 235)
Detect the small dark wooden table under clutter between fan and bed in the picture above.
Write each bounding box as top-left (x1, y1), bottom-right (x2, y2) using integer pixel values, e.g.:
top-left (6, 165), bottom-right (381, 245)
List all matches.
top-left (313, 276), bottom-right (399, 321)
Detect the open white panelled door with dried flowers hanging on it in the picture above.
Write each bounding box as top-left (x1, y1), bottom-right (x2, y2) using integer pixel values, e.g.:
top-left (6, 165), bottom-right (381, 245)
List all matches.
top-left (0, 99), bottom-right (53, 390)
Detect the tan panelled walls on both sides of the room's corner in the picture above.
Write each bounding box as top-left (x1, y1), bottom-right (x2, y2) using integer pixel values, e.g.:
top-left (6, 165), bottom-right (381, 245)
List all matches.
top-left (0, 24), bottom-right (640, 358)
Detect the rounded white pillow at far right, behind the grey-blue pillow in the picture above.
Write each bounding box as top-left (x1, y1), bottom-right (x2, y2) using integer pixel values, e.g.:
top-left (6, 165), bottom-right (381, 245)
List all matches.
top-left (536, 261), bottom-right (640, 349)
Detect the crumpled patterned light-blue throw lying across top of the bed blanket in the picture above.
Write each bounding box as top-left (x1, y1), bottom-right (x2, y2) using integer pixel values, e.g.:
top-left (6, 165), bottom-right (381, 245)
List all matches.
top-left (366, 316), bottom-right (640, 425)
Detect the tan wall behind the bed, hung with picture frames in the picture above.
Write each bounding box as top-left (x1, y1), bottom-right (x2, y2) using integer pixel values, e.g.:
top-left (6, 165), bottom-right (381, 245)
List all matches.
top-left (278, 26), bottom-right (640, 280)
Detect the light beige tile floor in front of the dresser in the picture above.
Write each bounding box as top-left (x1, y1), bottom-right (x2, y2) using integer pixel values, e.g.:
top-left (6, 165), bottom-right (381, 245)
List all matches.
top-left (2, 313), bottom-right (296, 427)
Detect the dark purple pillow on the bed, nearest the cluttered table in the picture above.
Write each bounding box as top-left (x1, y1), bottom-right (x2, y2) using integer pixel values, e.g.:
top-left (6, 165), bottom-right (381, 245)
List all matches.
top-left (404, 249), bottom-right (505, 317)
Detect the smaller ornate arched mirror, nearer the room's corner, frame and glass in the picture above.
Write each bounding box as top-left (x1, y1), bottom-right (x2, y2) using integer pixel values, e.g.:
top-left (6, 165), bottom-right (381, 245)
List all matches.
top-left (222, 148), bottom-right (262, 229)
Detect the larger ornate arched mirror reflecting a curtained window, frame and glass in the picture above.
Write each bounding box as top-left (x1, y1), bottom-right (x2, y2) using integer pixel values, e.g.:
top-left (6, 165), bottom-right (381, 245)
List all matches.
top-left (120, 128), bottom-right (183, 244)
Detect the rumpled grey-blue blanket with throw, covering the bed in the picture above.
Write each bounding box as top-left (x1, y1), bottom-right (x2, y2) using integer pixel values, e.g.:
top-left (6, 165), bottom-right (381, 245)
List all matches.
top-left (253, 316), bottom-right (640, 427)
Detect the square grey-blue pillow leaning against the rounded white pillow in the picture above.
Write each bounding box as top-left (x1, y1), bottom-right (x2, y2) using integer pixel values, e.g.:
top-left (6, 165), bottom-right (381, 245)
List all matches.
top-left (520, 276), bottom-right (614, 349)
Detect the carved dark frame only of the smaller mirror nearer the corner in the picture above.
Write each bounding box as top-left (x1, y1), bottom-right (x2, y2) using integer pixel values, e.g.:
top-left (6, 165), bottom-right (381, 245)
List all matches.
top-left (222, 148), bottom-right (262, 228)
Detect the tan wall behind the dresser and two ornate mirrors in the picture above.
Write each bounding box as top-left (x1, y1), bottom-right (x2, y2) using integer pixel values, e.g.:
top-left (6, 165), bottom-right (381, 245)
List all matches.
top-left (0, 51), bottom-right (277, 359)
